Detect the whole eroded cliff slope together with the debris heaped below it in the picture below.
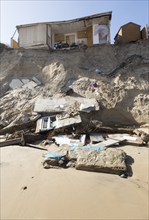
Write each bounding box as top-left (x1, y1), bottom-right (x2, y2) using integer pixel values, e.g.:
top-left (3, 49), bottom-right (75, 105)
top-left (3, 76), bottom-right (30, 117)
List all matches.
top-left (0, 41), bottom-right (149, 174)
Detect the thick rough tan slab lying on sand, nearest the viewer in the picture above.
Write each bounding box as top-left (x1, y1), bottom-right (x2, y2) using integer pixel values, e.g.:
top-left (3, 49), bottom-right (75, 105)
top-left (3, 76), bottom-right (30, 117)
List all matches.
top-left (76, 148), bottom-right (127, 175)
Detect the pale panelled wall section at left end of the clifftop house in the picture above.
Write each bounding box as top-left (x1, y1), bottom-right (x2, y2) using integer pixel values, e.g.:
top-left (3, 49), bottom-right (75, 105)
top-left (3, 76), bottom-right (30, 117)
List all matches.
top-left (19, 24), bottom-right (47, 47)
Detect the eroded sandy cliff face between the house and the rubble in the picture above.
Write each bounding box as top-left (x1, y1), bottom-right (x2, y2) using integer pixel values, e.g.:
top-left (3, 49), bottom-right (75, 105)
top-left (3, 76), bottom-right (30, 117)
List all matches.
top-left (0, 41), bottom-right (149, 129)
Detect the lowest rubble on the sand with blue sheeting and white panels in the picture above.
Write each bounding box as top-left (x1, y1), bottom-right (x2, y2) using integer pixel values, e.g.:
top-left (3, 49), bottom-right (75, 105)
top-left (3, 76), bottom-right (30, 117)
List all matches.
top-left (40, 133), bottom-right (147, 177)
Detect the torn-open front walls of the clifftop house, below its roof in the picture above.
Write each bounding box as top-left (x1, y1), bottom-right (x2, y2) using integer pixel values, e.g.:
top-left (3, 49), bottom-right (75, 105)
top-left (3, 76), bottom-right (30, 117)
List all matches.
top-left (18, 16), bottom-right (110, 48)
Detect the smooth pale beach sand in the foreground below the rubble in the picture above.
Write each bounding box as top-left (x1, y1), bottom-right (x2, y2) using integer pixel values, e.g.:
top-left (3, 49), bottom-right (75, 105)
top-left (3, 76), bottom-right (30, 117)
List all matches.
top-left (0, 145), bottom-right (149, 220)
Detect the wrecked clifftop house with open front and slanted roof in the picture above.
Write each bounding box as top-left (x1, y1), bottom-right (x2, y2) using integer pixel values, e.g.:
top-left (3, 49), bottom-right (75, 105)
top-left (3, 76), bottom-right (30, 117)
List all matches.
top-left (12, 12), bottom-right (112, 48)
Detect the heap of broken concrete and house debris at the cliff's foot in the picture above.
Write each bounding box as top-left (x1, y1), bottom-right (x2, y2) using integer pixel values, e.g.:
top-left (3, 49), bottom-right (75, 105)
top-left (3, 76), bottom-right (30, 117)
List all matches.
top-left (0, 89), bottom-right (148, 176)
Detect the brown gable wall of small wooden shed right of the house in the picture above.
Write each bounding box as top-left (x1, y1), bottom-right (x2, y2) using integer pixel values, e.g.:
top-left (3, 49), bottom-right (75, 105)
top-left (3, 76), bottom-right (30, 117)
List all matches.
top-left (117, 24), bottom-right (141, 43)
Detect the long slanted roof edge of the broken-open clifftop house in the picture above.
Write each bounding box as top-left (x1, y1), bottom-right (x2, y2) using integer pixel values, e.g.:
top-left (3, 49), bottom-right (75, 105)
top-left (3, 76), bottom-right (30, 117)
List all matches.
top-left (16, 11), bottom-right (112, 29)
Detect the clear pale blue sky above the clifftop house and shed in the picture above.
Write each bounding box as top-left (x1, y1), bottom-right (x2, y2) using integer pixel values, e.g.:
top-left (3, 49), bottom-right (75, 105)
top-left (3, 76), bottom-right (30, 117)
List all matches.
top-left (0, 0), bottom-right (149, 45)
